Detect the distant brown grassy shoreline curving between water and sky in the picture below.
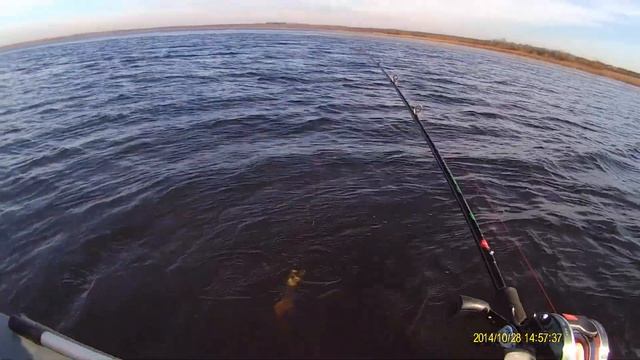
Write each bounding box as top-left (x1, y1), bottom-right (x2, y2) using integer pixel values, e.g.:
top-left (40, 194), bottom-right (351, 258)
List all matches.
top-left (5, 22), bottom-right (640, 87)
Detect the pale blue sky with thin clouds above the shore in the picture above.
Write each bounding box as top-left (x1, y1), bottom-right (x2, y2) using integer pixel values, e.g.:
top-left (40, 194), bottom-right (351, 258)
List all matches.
top-left (0, 0), bottom-right (640, 72)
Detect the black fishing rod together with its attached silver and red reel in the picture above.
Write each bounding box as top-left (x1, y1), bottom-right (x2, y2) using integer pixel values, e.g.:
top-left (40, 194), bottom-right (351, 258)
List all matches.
top-left (369, 55), bottom-right (609, 360)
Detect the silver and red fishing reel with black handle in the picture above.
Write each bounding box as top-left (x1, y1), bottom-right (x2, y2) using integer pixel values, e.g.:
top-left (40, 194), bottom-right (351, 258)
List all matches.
top-left (457, 296), bottom-right (609, 360)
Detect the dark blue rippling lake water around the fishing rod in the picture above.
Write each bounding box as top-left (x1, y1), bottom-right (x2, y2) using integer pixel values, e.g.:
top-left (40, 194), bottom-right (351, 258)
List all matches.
top-left (0, 31), bottom-right (640, 357)
